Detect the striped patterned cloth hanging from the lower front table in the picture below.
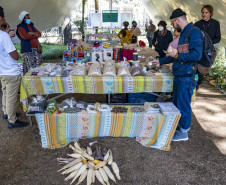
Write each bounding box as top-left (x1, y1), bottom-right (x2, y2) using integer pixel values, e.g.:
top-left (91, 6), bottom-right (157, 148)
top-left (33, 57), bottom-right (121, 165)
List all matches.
top-left (35, 106), bottom-right (181, 151)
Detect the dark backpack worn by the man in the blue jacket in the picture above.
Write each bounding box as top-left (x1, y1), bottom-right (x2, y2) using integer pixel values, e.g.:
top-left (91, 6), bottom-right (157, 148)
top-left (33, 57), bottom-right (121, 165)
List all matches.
top-left (185, 26), bottom-right (216, 75)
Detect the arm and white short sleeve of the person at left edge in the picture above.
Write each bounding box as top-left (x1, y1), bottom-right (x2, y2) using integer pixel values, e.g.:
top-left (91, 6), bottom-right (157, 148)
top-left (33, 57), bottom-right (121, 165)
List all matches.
top-left (2, 33), bottom-right (19, 60)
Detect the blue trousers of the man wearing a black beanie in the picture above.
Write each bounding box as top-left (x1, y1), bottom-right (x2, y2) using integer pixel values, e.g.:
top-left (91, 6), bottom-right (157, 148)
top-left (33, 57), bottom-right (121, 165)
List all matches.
top-left (173, 77), bottom-right (197, 132)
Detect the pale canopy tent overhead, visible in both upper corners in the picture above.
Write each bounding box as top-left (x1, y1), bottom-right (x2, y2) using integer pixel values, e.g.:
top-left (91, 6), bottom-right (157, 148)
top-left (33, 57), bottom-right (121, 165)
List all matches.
top-left (0, 0), bottom-right (226, 47)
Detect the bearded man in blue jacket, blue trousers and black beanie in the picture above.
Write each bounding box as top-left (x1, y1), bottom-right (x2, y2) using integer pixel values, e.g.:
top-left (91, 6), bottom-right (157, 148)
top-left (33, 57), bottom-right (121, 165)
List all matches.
top-left (153, 8), bottom-right (203, 141)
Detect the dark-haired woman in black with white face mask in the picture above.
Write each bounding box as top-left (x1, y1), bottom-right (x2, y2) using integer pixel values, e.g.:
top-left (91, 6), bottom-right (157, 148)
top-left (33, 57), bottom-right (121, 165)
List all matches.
top-left (153, 21), bottom-right (173, 58)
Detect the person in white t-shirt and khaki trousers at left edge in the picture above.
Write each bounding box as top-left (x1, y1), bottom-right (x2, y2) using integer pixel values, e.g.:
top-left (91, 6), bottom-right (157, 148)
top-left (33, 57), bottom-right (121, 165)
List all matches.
top-left (0, 6), bottom-right (28, 129)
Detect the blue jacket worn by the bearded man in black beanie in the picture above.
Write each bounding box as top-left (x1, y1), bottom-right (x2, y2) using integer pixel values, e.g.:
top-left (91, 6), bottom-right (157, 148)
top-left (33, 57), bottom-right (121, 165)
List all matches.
top-left (159, 23), bottom-right (203, 77)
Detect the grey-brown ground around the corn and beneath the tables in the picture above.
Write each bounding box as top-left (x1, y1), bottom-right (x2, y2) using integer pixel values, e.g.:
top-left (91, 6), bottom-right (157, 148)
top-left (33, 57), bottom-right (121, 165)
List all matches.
top-left (0, 84), bottom-right (226, 185)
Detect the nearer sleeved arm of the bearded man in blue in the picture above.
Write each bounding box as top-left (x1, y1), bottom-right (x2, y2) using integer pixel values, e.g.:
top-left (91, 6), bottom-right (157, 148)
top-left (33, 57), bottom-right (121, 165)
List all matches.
top-left (177, 29), bottom-right (203, 62)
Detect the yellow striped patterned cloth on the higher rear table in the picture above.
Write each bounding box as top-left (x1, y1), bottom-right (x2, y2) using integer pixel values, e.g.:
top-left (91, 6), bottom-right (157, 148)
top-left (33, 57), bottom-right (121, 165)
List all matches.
top-left (20, 74), bottom-right (173, 110)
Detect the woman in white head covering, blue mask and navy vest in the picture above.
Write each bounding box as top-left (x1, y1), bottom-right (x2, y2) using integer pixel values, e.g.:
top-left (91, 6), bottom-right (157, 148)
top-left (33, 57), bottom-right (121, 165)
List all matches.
top-left (16, 11), bottom-right (42, 74)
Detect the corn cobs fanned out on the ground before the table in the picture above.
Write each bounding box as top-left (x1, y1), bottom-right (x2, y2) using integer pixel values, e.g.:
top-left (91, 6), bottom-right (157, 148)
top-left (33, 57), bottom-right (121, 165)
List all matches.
top-left (57, 142), bottom-right (121, 185)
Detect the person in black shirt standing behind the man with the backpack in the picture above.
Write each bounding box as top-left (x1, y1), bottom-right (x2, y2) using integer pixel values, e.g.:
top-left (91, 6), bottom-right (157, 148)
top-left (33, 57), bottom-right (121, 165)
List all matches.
top-left (195, 5), bottom-right (221, 89)
